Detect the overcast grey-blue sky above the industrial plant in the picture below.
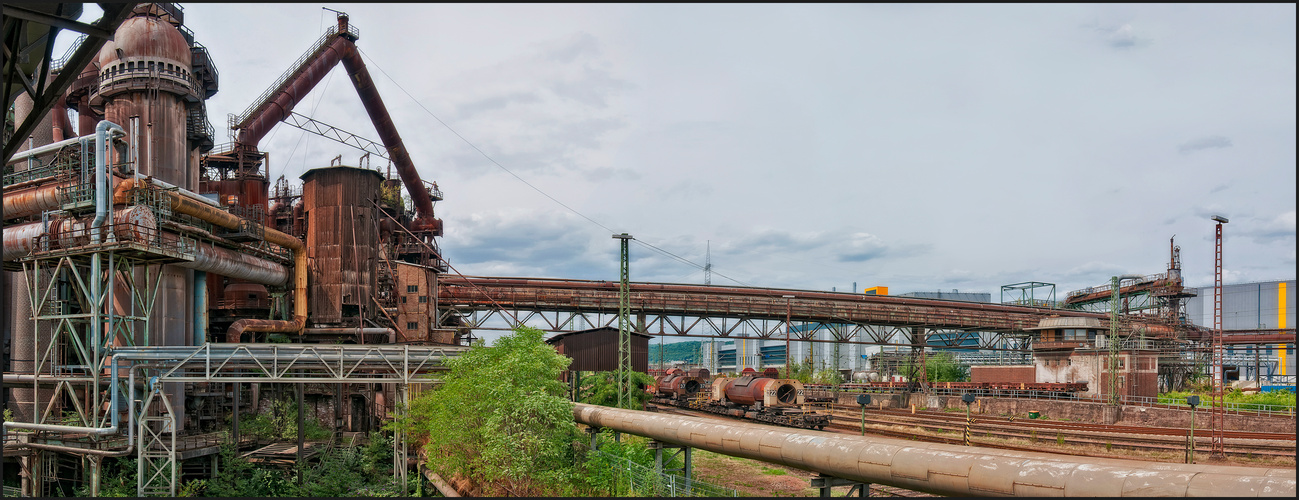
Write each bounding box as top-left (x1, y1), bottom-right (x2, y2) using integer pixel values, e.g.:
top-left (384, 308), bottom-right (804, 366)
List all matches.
top-left (63, 4), bottom-right (1296, 301)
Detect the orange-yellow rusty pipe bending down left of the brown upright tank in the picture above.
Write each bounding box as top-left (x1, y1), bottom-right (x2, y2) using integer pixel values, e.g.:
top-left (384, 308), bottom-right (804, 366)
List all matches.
top-left (113, 179), bottom-right (307, 343)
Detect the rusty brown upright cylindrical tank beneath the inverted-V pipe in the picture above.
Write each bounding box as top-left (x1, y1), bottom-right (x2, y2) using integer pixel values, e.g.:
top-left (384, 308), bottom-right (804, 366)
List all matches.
top-left (301, 166), bottom-right (383, 325)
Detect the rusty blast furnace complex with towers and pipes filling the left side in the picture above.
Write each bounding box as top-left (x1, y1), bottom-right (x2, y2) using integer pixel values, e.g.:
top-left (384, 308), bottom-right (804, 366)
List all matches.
top-left (3, 4), bottom-right (468, 496)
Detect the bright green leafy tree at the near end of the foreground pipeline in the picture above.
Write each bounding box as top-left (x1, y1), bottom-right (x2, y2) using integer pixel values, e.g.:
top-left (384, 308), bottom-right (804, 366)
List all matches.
top-left (392, 327), bottom-right (579, 496)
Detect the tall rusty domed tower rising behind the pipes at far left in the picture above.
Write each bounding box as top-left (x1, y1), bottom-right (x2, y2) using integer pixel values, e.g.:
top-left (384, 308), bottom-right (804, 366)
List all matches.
top-left (88, 4), bottom-right (201, 431)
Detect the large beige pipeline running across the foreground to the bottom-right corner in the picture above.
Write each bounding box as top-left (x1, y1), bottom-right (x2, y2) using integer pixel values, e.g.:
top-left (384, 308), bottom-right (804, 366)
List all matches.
top-left (573, 403), bottom-right (1295, 497)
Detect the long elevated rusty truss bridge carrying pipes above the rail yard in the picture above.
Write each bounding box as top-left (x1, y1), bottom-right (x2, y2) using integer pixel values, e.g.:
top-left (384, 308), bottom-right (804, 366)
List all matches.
top-left (436, 272), bottom-right (1167, 351)
